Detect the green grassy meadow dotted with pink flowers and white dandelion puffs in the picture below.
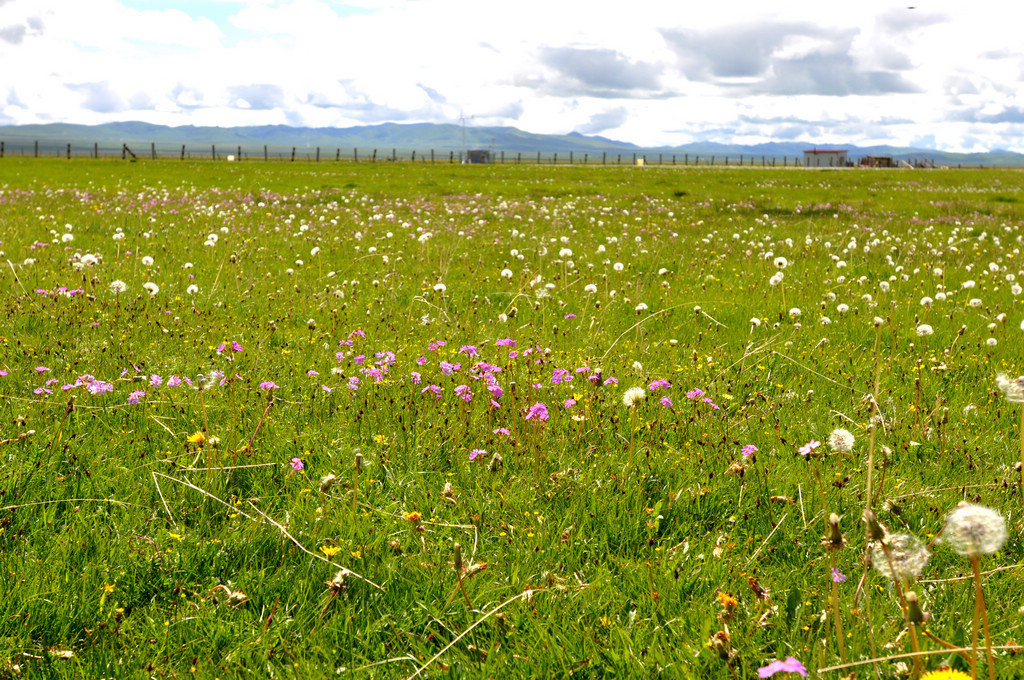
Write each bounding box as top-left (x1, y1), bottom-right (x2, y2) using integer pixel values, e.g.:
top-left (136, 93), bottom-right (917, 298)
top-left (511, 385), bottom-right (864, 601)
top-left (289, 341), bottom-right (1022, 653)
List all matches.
top-left (0, 159), bottom-right (1024, 678)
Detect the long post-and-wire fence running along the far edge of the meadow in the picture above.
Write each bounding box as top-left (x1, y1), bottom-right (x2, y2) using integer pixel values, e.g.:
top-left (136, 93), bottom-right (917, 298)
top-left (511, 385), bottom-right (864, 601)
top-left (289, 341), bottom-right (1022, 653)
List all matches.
top-left (0, 139), bottom-right (950, 168)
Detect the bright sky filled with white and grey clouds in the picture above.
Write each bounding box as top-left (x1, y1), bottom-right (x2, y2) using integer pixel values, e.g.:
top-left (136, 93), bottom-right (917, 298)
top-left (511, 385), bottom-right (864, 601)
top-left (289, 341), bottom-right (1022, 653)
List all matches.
top-left (0, 0), bottom-right (1024, 152)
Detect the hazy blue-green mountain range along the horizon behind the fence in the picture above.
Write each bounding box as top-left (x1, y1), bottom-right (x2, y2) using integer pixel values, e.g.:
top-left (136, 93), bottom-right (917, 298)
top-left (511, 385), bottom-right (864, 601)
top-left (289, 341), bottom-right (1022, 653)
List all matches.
top-left (0, 122), bottom-right (1024, 166)
